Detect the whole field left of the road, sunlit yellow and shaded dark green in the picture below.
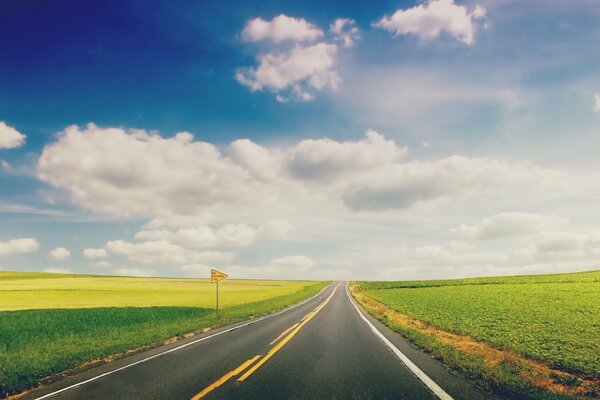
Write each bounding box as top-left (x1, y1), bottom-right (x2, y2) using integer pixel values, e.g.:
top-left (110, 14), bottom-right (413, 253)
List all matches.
top-left (0, 272), bottom-right (327, 397)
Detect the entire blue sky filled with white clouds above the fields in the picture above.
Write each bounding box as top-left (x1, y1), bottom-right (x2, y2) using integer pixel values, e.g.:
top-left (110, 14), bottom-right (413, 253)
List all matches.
top-left (0, 0), bottom-right (600, 280)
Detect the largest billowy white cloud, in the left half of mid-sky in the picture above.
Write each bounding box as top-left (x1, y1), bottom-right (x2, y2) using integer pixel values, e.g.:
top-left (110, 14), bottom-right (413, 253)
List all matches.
top-left (38, 124), bottom-right (260, 218)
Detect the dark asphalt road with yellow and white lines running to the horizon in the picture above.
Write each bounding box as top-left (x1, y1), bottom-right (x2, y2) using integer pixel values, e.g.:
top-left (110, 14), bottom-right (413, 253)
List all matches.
top-left (24, 283), bottom-right (493, 400)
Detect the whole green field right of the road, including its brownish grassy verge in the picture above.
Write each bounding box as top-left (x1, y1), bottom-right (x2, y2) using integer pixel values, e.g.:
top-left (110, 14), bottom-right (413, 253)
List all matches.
top-left (353, 271), bottom-right (600, 399)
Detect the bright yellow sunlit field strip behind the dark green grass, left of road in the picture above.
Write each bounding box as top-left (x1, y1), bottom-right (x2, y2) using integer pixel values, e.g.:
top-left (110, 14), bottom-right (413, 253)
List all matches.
top-left (0, 272), bottom-right (312, 311)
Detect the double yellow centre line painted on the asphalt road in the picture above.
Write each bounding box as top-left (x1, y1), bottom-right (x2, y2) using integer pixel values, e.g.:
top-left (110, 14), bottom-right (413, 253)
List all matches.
top-left (192, 284), bottom-right (339, 400)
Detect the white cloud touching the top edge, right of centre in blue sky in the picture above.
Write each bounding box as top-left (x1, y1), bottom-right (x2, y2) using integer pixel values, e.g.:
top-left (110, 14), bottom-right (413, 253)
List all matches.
top-left (374, 0), bottom-right (485, 44)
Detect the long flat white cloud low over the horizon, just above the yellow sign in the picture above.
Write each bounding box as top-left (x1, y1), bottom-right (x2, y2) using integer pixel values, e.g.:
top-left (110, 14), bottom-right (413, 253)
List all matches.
top-left (106, 240), bottom-right (234, 264)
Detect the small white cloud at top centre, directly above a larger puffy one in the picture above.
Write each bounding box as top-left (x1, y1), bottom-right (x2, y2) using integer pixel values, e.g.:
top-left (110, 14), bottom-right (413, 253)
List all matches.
top-left (242, 14), bottom-right (323, 43)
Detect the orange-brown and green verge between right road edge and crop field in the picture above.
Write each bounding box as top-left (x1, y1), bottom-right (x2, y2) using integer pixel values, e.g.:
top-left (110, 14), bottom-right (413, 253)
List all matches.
top-left (349, 284), bottom-right (600, 400)
